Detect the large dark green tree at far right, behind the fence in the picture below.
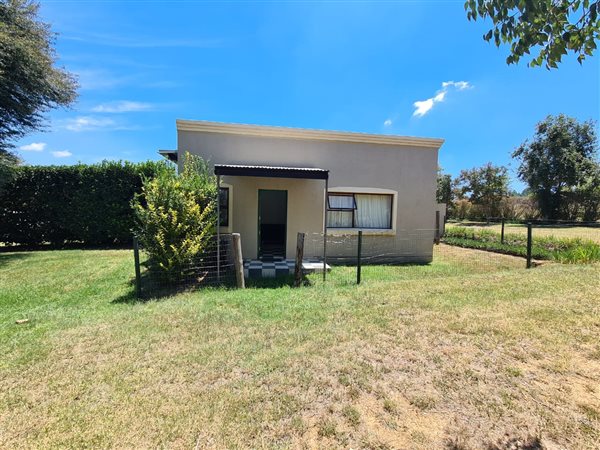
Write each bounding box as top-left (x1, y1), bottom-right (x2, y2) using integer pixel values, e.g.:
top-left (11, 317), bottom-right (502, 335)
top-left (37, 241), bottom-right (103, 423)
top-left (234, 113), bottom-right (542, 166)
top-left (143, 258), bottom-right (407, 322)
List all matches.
top-left (512, 114), bottom-right (600, 220)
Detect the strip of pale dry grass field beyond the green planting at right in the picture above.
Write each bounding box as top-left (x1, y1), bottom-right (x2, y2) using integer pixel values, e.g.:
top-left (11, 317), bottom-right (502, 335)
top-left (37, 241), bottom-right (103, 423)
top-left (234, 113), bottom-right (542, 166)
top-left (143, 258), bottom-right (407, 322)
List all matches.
top-left (446, 221), bottom-right (600, 242)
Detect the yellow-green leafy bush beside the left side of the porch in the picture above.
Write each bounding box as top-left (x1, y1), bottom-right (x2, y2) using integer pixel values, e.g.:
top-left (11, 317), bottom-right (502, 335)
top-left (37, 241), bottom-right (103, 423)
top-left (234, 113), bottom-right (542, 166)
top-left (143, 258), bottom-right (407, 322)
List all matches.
top-left (133, 153), bottom-right (217, 281)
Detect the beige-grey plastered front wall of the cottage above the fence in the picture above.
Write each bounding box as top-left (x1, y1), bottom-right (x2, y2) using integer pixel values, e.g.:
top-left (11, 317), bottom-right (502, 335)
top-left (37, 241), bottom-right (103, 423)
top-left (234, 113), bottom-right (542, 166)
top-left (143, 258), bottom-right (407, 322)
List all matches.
top-left (178, 130), bottom-right (438, 262)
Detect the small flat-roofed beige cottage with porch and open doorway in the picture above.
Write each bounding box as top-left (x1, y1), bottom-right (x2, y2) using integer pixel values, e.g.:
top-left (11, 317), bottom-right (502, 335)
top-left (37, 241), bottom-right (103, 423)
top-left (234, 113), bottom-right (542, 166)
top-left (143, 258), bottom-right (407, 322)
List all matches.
top-left (160, 120), bottom-right (443, 262)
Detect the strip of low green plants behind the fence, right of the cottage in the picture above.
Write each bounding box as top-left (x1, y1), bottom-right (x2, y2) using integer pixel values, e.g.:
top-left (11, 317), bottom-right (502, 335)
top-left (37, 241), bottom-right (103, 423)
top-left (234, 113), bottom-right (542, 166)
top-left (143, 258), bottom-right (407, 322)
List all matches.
top-left (443, 227), bottom-right (600, 263)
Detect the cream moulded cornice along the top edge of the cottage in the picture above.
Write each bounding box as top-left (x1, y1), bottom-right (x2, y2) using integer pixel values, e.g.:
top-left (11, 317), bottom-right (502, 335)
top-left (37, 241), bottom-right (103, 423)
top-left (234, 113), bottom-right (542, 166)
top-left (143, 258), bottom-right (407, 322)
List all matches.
top-left (177, 119), bottom-right (444, 150)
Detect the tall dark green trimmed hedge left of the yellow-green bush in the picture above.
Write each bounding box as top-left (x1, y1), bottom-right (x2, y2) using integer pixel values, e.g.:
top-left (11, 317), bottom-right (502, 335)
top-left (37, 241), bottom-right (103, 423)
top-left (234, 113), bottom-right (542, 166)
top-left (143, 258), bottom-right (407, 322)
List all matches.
top-left (0, 161), bottom-right (175, 245)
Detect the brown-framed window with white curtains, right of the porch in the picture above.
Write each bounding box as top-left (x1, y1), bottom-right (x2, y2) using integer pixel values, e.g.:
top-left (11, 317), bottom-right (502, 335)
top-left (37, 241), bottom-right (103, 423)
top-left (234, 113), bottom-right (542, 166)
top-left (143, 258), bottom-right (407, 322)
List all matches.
top-left (327, 193), bottom-right (392, 229)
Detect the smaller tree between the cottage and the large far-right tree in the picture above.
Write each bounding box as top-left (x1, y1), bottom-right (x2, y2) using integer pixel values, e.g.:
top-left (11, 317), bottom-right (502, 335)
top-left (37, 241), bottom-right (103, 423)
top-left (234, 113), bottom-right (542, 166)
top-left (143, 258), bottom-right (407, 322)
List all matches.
top-left (455, 163), bottom-right (508, 217)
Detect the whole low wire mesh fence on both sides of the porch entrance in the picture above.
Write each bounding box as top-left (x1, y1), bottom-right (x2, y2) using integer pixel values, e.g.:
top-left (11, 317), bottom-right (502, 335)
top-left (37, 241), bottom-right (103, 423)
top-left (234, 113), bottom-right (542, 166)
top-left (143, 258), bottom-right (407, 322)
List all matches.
top-left (135, 218), bottom-right (600, 298)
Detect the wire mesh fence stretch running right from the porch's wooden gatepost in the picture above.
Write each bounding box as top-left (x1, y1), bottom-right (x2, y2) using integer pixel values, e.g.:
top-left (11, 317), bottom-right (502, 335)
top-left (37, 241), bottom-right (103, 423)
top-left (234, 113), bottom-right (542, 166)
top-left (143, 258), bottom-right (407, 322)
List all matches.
top-left (296, 218), bottom-right (600, 285)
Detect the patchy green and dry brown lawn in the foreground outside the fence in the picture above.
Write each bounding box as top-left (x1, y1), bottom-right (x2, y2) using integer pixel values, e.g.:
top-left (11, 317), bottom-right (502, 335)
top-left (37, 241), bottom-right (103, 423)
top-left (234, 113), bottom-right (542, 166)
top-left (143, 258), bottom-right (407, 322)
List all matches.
top-left (0, 246), bottom-right (600, 449)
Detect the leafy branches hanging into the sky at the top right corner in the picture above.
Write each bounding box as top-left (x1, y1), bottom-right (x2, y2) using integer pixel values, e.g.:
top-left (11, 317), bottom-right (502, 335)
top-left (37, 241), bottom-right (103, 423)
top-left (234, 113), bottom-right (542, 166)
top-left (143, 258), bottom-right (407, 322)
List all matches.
top-left (465, 0), bottom-right (600, 69)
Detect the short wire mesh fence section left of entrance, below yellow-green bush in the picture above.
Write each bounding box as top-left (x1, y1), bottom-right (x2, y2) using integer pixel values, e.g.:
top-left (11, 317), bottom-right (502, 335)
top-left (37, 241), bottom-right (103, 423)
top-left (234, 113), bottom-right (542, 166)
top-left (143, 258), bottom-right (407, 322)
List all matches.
top-left (134, 234), bottom-right (236, 298)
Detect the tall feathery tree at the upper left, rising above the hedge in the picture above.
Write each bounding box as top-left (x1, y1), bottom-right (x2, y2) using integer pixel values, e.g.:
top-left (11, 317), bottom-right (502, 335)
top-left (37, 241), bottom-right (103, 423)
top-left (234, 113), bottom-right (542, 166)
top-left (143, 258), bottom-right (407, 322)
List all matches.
top-left (0, 0), bottom-right (77, 155)
